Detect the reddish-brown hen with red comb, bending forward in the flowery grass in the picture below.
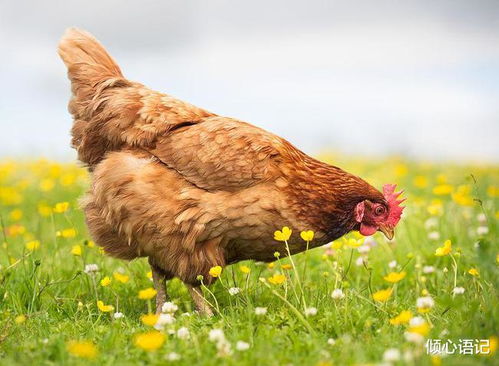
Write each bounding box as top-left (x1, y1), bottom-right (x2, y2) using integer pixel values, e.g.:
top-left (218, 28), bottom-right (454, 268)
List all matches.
top-left (59, 29), bottom-right (402, 313)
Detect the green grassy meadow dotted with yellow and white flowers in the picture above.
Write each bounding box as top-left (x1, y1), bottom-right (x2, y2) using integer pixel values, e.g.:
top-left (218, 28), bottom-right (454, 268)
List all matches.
top-left (0, 155), bottom-right (499, 366)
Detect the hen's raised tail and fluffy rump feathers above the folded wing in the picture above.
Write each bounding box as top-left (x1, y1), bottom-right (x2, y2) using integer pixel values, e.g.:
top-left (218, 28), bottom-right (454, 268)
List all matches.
top-left (59, 28), bottom-right (213, 170)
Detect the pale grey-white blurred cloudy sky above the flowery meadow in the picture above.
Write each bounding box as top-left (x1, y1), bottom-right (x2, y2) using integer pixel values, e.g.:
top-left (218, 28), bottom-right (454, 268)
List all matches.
top-left (0, 0), bottom-right (499, 162)
